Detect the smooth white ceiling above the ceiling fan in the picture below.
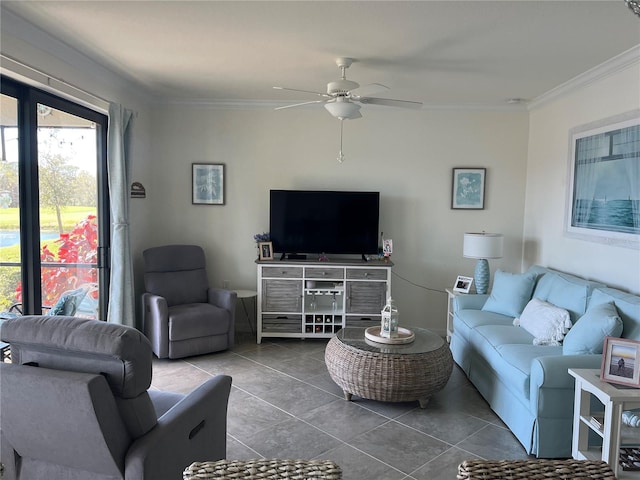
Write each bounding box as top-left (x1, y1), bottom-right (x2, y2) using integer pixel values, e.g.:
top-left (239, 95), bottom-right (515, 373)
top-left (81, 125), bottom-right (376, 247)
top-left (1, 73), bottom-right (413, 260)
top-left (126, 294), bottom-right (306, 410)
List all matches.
top-left (1, 0), bottom-right (640, 106)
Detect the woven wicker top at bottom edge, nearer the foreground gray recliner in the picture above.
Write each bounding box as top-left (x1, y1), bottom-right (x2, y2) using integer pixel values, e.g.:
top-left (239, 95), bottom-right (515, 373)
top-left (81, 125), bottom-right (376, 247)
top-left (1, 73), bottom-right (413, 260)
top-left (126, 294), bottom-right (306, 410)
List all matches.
top-left (182, 458), bottom-right (342, 480)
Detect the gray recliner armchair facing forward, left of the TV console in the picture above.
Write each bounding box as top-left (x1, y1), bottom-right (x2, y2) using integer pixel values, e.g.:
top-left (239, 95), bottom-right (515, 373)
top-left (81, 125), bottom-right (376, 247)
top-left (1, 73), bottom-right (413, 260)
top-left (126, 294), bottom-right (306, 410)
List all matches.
top-left (142, 245), bottom-right (237, 358)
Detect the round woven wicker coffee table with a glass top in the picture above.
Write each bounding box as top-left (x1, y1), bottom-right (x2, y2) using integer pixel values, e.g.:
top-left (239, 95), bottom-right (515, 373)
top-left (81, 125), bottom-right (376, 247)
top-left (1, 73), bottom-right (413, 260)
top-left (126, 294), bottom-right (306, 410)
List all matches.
top-left (324, 327), bottom-right (453, 408)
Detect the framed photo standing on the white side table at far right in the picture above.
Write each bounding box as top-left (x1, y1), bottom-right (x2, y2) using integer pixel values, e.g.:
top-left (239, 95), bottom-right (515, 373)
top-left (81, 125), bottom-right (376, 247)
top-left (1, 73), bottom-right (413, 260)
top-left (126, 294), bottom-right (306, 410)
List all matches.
top-left (600, 337), bottom-right (640, 388)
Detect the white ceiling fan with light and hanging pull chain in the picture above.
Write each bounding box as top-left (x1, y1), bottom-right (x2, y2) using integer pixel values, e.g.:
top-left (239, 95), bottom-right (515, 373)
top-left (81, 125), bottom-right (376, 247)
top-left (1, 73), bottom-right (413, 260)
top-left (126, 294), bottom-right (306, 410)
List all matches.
top-left (273, 57), bottom-right (422, 163)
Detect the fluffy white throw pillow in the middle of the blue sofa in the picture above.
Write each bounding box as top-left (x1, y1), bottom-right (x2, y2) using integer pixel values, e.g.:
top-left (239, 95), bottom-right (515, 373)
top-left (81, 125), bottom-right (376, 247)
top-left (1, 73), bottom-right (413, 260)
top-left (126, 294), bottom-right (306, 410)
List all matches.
top-left (513, 298), bottom-right (571, 345)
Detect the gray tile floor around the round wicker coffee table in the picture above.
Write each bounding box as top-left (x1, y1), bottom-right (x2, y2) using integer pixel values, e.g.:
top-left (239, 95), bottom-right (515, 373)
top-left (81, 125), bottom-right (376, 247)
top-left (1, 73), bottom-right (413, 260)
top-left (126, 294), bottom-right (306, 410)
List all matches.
top-left (152, 336), bottom-right (528, 480)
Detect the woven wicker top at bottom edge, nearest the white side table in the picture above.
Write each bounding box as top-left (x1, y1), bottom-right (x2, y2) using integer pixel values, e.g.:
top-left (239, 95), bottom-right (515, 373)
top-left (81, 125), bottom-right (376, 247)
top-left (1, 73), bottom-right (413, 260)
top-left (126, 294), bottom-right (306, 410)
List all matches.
top-left (458, 460), bottom-right (616, 480)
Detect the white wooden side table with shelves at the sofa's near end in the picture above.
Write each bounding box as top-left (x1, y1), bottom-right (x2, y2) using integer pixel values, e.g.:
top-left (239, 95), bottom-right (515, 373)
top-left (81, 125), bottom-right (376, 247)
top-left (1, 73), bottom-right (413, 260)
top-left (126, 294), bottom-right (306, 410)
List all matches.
top-left (569, 368), bottom-right (640, 479)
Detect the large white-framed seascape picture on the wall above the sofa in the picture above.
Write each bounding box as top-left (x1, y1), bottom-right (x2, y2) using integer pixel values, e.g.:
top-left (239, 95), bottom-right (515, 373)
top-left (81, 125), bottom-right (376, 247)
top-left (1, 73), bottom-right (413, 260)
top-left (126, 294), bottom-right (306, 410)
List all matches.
top-left (565, 110), bottom-right (640, 249)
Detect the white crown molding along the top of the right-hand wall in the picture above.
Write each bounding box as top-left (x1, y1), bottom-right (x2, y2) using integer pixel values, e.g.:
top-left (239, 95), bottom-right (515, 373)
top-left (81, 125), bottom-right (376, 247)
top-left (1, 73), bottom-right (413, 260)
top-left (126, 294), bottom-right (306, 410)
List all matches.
top-left (527, 44), bottom-right (640, 110)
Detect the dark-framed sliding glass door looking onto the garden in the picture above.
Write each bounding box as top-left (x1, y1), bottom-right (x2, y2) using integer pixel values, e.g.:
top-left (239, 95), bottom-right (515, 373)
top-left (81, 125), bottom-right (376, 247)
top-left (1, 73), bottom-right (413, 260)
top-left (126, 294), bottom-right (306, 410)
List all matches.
top-left (0, 78), bottom-right (109, 319)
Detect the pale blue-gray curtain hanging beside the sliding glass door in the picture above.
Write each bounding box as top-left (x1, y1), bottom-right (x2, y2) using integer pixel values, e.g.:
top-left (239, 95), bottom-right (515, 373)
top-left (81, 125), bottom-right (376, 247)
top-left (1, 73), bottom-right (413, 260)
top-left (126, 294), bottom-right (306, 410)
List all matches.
top-left (107, 103), bottom-right (135, 327)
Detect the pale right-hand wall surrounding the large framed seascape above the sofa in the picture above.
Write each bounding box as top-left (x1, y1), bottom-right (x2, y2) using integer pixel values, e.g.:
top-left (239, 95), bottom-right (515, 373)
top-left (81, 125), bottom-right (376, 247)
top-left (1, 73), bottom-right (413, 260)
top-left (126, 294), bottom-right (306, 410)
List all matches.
top-left (523, 63), bottom-right (640, 293)
